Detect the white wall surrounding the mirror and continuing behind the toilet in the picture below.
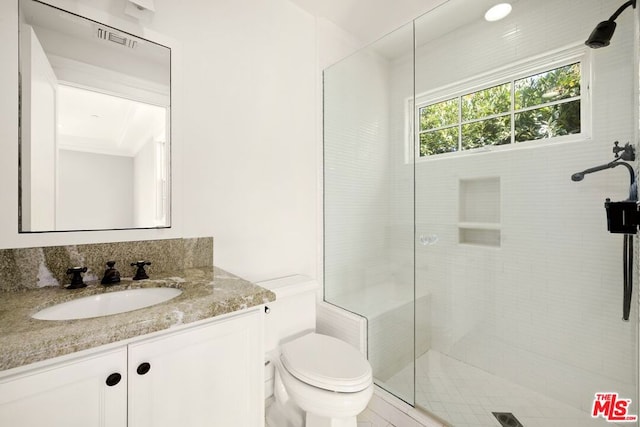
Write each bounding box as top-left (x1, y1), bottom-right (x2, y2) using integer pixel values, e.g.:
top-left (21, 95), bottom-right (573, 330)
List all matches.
top-left (0, 0), bottom-right (319, 280)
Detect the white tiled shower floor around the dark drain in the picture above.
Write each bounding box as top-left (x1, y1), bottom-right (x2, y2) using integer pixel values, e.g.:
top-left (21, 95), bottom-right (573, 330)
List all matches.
top-left (385, 350), bottom-right (638, 427)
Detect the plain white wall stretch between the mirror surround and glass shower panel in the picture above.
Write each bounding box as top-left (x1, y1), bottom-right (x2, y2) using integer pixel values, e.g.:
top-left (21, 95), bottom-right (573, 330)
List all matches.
top-left (155, 0), bottom-right (318, 280)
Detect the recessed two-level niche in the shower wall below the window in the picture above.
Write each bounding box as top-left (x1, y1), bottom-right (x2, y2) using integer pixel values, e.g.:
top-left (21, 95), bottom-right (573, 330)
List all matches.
top-left (458, 177), bottom-right (501, 248)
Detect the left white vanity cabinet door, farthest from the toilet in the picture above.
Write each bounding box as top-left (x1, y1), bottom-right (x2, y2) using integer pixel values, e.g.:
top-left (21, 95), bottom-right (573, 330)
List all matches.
top-left (0, 347), bottom-right (127, 427)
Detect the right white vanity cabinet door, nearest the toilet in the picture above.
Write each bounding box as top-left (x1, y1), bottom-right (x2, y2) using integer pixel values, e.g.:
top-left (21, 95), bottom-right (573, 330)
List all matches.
top-left (129, 310), bottom-right (264, 427)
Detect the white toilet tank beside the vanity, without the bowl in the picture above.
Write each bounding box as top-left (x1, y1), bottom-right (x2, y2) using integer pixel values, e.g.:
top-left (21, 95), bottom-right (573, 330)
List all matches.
top-left (257, 274), bottom-right (320, 353)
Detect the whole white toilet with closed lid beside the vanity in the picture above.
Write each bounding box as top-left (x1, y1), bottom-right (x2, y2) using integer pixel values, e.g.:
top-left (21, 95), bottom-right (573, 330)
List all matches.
top-left (258, 275), bottom-right (374, 427)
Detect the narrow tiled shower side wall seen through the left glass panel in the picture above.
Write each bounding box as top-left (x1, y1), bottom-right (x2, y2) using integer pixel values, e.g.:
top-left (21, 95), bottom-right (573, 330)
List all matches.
top-left (324, 46), bottom-right (390, 309)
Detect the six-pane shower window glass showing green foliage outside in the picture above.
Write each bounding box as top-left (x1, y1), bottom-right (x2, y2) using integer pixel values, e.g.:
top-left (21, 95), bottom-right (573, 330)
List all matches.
top-left (416, 47), bottom-right (588, 157)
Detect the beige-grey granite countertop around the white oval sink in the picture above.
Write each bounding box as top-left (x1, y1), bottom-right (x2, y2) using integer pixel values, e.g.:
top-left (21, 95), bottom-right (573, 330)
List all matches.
top-left (0, 267), bottom-right (275, 371)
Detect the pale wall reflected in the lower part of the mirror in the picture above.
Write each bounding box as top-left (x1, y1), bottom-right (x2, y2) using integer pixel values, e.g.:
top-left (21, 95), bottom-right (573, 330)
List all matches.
top-left (56, 150), bottom-right (133, 230)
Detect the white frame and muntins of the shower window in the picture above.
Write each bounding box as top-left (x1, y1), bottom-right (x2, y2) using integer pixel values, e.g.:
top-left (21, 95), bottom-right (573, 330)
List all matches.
top-left (405, 44), bottom-right (592, 162)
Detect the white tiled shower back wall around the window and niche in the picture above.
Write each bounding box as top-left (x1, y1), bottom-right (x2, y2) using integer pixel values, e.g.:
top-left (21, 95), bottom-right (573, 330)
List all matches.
top-left (391, 0), bottom-right (637, 410)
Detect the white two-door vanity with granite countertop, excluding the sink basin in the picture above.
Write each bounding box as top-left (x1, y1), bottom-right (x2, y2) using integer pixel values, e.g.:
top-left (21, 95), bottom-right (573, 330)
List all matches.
top-left (0, 268), bottom-right (275, 427)
